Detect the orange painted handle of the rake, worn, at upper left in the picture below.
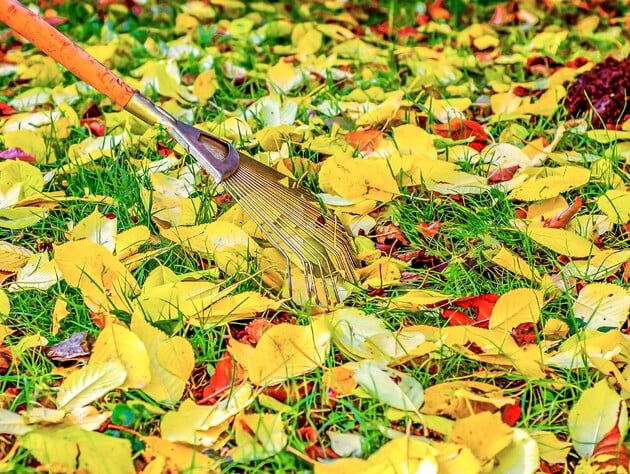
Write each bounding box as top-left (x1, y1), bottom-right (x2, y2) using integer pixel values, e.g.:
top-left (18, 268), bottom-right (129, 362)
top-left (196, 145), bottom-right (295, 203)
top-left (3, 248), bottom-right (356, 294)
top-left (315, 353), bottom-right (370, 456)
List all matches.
top-left (0, 0), bottom-right (134, 107)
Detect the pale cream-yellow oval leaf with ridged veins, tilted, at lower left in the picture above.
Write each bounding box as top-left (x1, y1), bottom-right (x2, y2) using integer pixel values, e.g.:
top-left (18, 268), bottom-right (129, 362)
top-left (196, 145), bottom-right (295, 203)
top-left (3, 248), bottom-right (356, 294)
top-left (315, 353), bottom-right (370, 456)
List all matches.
top-left (57, 360), bottom-right (127, 411)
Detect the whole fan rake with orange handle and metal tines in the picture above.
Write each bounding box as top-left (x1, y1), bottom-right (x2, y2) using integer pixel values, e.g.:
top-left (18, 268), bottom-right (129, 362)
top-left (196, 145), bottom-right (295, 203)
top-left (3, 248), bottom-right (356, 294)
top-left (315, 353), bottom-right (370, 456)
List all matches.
top-left (0, 0), bottom-right (358, 304)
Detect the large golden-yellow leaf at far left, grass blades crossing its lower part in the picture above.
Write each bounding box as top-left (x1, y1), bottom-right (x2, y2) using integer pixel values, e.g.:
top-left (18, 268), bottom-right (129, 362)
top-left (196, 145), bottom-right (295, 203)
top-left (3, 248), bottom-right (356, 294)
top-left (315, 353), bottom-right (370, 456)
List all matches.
top-left (55, 240), bottom-right (138, 314)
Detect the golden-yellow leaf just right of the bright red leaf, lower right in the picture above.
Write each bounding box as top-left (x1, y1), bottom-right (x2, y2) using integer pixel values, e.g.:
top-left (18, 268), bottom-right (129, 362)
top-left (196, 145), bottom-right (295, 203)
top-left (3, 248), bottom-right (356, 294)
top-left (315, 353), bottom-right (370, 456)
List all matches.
top-left (488, 288), bottom-right (545, 332)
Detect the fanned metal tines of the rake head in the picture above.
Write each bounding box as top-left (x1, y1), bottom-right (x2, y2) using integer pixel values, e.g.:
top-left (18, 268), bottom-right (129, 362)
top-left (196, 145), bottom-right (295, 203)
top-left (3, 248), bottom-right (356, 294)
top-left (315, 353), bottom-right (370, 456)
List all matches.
top-left (222, 153), bottom-right (358, 304)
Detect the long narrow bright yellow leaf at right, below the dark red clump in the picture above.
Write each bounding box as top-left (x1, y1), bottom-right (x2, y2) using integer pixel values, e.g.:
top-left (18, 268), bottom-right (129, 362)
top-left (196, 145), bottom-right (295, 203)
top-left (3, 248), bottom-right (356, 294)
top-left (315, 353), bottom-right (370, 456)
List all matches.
top-left (508, 166), bottom-right (591, 201)
